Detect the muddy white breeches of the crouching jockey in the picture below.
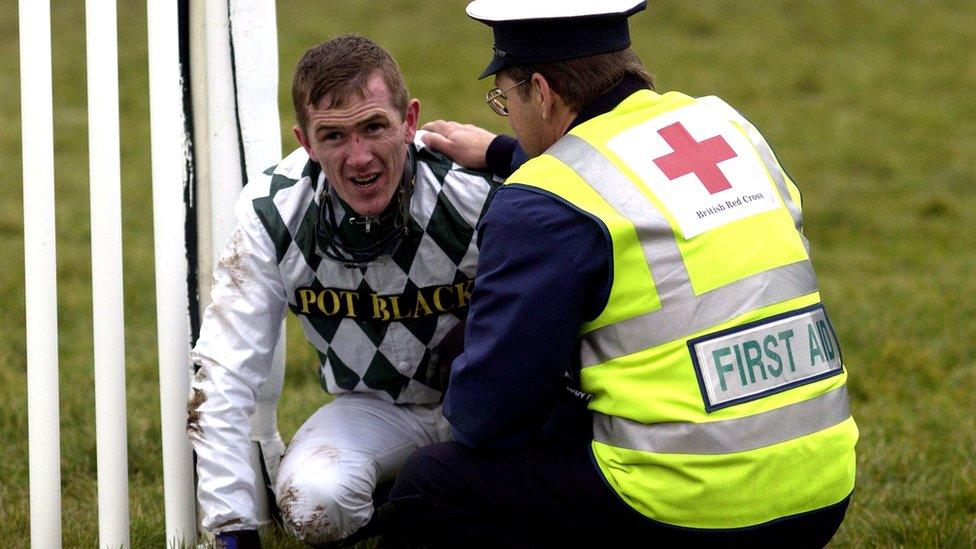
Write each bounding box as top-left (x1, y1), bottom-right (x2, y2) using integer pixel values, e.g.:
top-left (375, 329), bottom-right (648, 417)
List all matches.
top-left (275, 393), bottom-right (451, 544)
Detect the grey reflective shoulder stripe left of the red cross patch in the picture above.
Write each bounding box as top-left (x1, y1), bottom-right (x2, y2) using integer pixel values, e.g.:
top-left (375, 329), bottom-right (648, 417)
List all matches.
top-left (546, 135), bottom-right (694, 303)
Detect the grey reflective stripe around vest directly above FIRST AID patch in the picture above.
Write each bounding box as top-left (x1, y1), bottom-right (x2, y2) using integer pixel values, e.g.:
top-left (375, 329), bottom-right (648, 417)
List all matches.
top-left (580, 260), bottom-right (817, 368)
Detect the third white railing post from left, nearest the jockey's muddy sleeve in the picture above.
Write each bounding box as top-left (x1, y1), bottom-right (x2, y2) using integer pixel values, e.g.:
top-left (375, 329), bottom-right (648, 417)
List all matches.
top-left (147, 0), bottom-right (197, 547)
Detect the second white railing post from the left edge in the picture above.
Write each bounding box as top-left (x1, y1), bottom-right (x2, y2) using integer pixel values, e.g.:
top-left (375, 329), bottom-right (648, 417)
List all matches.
top-left (85, 0), bottom-right (129, 547)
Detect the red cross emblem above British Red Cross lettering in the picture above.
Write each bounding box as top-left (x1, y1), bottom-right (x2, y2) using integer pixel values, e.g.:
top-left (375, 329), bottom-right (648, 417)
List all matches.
top-left (654, 122), bottom-right (738, 194)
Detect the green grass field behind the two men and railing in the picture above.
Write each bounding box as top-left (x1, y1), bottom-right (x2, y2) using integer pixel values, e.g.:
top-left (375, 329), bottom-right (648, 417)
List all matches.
top-left (0, 0), bottom-right (976, 547)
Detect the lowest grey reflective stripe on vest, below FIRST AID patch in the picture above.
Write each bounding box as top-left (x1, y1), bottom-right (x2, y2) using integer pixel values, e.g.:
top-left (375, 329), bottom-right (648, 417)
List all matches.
top-left (593, 385), bottom-right (851, 455)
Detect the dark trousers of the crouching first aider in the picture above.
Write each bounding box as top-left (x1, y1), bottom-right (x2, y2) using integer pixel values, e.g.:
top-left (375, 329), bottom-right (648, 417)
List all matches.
top-left (388, 439), bottom-right (850, 548)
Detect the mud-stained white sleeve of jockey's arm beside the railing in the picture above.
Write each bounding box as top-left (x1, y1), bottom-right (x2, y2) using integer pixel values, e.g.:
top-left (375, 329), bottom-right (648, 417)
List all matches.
top-left (187, 197), bottom-right (286, 532)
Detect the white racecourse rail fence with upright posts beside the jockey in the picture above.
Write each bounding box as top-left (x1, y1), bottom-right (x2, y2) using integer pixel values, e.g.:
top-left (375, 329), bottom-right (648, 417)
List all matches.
top-left (19, 0), bottom-right (284, 549)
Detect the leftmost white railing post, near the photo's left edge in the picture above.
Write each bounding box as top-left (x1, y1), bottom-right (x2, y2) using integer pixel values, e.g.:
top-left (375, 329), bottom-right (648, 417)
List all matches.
top-left (19, 0), bottom-right (61, 549)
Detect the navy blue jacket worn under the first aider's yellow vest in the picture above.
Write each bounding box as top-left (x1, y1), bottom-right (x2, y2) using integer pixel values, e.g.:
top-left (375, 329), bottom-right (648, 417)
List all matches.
top-left (444, 78), bottom-right (647, 448)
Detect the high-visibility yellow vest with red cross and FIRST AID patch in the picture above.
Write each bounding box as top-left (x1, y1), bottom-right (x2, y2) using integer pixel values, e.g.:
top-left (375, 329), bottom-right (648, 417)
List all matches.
top-left (507, 90), bottom-right (858, 528)
